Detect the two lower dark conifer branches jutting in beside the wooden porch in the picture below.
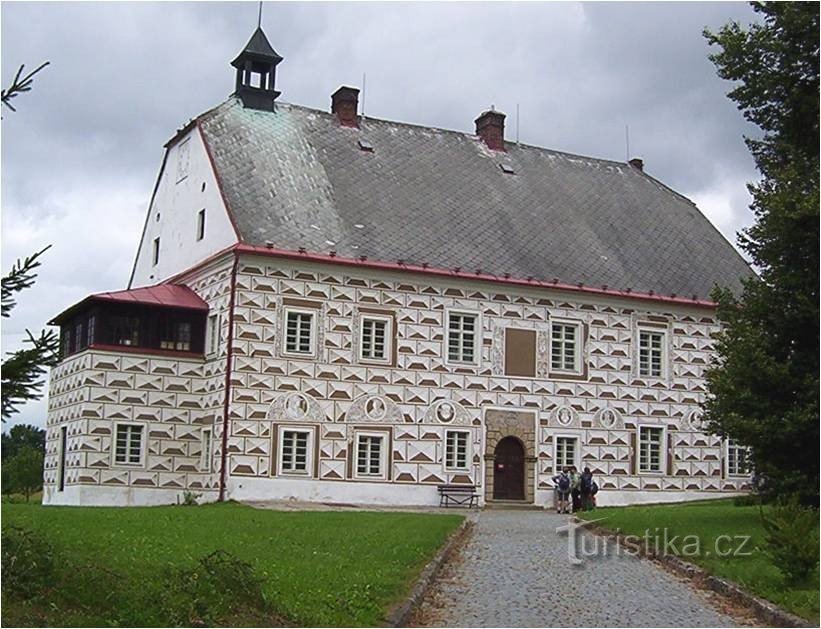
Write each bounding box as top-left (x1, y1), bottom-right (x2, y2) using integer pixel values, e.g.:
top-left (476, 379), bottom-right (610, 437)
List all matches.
top-left (1, 245), bottom-right (60, 421)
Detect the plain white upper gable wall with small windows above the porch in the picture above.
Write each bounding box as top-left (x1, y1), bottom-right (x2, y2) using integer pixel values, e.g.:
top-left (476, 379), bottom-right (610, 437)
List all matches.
top-left (129, 127), bottom-right (237, 288)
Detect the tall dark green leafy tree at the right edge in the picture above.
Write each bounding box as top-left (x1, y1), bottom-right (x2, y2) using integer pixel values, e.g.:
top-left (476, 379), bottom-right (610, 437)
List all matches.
top-left (704, 2), bottom-right (819, 505)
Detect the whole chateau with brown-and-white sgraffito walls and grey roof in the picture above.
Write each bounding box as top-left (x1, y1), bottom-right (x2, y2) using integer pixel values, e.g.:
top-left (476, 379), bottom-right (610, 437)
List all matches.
top-left (43, 29), bottom-right (751, 505)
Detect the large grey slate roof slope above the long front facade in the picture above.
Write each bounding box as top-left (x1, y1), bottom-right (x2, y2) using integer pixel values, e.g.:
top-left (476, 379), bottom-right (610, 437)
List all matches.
top-left (200, 98), bottom-right (751, 299)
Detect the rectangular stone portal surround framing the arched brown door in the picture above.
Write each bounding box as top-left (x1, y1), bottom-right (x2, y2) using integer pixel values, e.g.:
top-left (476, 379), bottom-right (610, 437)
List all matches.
top-left (485, 409), bottom-right (536, 503)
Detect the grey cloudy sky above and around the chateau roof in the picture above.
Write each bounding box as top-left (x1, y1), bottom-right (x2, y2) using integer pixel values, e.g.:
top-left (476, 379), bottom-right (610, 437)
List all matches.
top-left (0, 2), bottom-right (756, 425)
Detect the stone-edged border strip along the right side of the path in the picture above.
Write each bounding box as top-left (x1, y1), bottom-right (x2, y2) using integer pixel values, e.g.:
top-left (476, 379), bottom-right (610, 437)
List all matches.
top-left (574, 518), bottom-right (815, 627)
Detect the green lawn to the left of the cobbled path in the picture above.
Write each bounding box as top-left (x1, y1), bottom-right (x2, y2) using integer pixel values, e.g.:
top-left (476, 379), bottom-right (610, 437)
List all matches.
top-left (2, 503), bottom-right (462, 626)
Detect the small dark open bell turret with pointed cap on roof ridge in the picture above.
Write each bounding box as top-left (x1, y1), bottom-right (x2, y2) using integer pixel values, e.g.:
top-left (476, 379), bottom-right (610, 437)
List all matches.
top-left (231, 27), bottom-right (282, 111)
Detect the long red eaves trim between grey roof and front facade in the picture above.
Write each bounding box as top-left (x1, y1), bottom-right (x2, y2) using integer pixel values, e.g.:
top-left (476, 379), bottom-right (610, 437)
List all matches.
top-left (235, 244), bottom-right (716, 308)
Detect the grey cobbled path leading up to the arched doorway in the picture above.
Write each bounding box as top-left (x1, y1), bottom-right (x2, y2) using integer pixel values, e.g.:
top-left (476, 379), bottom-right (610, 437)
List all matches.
top-left (411, 510), bottom-right (738, 627)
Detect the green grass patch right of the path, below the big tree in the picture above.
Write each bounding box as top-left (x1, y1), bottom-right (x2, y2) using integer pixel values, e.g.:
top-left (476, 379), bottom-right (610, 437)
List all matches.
top-left (579, 500), bottom-right (819, 623)
